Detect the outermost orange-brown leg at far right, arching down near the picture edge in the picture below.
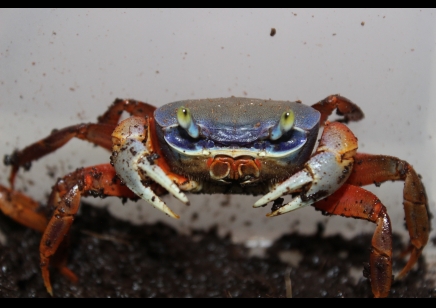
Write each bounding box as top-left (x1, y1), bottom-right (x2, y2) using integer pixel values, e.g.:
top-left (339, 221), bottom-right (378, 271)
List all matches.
top-left (347, 153), bottom-right (430, 279)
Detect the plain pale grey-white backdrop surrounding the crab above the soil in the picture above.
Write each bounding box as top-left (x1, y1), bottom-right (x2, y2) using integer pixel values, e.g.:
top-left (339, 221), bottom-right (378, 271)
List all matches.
top-left (0, 9), bottom-right (436, 280)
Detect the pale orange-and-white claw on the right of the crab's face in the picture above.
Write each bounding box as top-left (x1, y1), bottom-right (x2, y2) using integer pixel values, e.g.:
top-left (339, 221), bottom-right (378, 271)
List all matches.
top-left (254, 122), bottom-right (357, 216)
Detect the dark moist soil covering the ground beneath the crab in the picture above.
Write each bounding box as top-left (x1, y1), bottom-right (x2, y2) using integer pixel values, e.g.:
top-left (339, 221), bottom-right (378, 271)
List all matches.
top-left (0, 205), bottom-right (436, 297)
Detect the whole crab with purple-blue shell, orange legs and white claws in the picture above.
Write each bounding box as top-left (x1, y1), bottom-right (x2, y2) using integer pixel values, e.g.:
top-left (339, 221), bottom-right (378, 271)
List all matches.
top-left (0, 95), bottom-right (430, 297)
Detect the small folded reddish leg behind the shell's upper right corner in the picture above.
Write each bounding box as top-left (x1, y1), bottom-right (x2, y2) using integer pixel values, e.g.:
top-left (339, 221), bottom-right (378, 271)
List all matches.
top-left (312, 94), bottom-right (363, 125)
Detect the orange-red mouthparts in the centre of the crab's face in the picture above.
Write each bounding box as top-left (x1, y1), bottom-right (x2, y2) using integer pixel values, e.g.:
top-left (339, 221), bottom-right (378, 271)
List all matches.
top-left (207, 155), bottom-right (261, 184)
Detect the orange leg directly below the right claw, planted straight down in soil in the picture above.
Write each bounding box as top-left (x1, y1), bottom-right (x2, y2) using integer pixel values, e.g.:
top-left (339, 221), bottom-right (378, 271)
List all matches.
top-left (314, 184), bottom-right (392, 297)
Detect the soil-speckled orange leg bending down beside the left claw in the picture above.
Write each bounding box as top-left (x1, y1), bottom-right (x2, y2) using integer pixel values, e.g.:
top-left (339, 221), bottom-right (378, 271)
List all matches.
top-left (40, 164), bottom-right (145, 294)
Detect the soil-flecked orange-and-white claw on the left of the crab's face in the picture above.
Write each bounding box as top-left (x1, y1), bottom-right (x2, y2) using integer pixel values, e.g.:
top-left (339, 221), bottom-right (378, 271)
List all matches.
top-left (111, 117), bottom-right (189, 218)
